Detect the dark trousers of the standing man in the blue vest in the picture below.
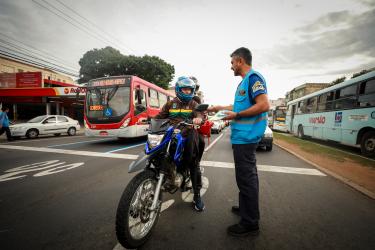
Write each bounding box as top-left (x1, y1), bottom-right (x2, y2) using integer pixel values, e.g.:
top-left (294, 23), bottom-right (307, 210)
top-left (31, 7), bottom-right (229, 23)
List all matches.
top-left (232, 143), bottom-right (259, 226)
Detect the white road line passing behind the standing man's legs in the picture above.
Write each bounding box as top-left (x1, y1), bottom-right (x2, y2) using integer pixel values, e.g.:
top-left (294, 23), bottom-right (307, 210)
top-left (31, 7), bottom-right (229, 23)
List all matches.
top-left (201, 161), bottom-right (326, 176)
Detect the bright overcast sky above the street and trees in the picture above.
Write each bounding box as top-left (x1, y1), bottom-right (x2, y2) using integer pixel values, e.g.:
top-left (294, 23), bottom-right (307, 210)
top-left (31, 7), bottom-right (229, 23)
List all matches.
top-left (0, 0), bottom-right (375, 104)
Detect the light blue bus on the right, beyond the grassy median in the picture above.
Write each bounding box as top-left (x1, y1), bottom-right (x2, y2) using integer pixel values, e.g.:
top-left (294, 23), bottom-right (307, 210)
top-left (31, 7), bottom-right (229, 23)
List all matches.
top-left (286, 71), bottom-right (375, 157)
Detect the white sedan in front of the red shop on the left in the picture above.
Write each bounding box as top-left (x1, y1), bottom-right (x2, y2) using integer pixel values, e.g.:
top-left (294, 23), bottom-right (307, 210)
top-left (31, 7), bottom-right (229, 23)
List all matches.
top-left (9, 115), bottom-right (81, 138)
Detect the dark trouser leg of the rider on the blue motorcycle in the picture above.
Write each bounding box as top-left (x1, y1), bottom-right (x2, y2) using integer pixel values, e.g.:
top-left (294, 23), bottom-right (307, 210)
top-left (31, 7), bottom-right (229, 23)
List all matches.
top-left (182, 129), bottom-right (202, 194)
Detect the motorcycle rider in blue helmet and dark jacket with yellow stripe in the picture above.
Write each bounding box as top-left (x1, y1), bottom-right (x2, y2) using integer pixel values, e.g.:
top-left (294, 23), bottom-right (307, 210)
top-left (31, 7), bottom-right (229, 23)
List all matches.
top-left (155, 76), bottom-right (205, 212)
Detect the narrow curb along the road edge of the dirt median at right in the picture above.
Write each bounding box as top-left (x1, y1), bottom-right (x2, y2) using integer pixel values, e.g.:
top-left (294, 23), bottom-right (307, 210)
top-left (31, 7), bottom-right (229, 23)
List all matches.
top-left (273, 141), bottom-right (375, 200)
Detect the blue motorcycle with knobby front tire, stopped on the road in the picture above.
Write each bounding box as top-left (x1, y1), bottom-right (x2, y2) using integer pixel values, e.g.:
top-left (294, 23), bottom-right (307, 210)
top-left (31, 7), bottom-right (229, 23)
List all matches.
top-left (116, 104), bottom-right (208, 248)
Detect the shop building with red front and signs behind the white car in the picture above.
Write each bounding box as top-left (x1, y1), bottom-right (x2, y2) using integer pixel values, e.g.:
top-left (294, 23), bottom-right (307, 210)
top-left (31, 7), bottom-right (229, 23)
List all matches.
top-left (0, 56), bottom-right (85, 121)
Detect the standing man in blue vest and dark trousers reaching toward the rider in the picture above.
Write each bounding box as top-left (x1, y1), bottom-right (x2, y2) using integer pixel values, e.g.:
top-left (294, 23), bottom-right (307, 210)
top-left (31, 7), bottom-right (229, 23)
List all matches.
top-left (208, 47), bottom-right (270, 236)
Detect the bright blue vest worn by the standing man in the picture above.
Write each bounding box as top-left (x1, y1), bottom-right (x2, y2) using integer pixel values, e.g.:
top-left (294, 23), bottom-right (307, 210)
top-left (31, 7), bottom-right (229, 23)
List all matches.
top-left (231, 70), bottom-right (267, 144)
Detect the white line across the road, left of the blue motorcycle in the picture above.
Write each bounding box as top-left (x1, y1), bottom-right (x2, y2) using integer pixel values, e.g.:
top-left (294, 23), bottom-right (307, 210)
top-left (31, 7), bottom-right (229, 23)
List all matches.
top-left (0, 145), bottom-right (138, 160)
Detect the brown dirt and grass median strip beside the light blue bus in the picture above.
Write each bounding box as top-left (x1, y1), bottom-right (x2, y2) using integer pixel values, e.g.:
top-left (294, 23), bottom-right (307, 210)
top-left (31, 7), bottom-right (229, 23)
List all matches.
top-left (274, 133), bottom-right (375, 199)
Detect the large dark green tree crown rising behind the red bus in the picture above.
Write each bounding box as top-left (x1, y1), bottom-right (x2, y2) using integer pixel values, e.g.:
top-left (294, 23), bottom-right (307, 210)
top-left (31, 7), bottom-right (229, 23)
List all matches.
top-left (78, 47), bottom-right (175, 89)
